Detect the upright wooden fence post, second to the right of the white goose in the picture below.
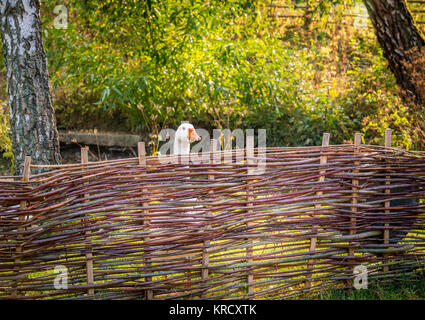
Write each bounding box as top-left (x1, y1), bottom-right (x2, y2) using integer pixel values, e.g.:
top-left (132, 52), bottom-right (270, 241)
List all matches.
top-left (246, 135), bottom-right (254, 297)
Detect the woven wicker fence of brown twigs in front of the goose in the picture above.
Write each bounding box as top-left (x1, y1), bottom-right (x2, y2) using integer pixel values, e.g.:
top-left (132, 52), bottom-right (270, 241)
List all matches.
top-left (0, 132), bottom-right (425, 299)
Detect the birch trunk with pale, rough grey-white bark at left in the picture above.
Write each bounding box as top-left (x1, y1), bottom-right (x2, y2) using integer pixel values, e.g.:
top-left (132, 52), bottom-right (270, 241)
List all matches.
top-left (0, 0), bottom-right (60, 175)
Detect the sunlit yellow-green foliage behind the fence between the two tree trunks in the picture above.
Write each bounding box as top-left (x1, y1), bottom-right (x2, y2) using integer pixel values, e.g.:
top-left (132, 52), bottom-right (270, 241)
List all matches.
top-left (3, 0), bottom-right (415, 164)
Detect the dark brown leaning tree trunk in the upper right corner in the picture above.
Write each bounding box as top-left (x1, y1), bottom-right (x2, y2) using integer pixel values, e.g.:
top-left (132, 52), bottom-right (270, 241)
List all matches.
top-left (363, 0), bottom-right (425, 107)
